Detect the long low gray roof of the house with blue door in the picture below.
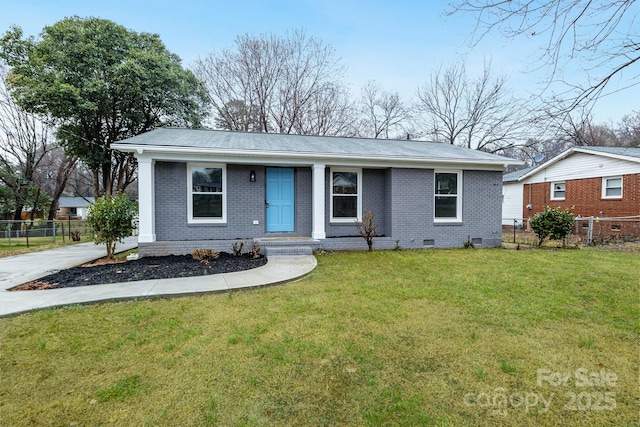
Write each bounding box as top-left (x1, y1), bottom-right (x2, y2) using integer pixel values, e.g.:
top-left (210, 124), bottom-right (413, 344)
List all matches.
top-left (112, 128), bottom-right (522, 165)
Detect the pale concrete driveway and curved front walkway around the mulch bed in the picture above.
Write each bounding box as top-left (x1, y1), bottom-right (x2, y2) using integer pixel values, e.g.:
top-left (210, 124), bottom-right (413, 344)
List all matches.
top-left (0, 238), bottom-right (317, 317)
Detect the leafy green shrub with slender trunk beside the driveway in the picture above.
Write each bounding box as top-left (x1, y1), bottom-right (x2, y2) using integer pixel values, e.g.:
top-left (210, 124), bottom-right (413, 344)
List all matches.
top-left (87, 193), bottom-right (137, 259)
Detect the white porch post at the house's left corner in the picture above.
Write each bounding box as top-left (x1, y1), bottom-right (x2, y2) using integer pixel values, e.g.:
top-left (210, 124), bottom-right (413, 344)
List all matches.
top-left (137, 155), bottom-right (156, 243)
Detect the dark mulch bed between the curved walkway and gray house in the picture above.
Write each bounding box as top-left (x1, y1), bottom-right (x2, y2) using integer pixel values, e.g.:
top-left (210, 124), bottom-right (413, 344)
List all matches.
top-left (10, 252), bottom-right (267, 291)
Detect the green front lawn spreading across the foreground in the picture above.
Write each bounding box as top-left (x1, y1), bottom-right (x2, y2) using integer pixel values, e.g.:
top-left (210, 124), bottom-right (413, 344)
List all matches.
top-left (0, 249), bottom-right (640, 426)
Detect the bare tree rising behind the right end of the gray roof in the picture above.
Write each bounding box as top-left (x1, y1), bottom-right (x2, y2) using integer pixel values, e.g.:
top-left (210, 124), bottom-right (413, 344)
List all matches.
top-left (417, 63), bottom-right (524, 152)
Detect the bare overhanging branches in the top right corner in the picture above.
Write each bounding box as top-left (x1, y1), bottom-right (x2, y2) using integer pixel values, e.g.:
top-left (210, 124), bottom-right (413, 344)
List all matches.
top-left (450, 0), bottom-right (640, 112)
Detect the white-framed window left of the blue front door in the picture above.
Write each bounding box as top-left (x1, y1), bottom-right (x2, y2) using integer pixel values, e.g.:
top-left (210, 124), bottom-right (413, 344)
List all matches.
top-left (187, 164), bottom-right (226, 223)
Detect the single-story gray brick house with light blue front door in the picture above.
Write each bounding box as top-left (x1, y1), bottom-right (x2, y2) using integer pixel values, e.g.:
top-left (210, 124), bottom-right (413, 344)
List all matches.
top-left (112, 128), bottom-right (520, 256)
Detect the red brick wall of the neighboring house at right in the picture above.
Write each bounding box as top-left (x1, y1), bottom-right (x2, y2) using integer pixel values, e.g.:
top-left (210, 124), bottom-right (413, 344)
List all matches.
top-left (522, 174), bottom-right (640, 218)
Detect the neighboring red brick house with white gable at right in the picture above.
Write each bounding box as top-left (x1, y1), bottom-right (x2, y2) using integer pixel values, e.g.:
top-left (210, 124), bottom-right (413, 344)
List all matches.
top-left (505, 147), bottom-right (640, 232)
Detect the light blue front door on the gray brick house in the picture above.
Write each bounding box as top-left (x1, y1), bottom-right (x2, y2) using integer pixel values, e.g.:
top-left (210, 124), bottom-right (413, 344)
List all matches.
top-left (267, 168), bottom-right (295, 232)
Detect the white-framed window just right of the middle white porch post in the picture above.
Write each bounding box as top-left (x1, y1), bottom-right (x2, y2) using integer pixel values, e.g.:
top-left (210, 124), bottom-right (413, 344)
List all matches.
top-left (331, 169), bottom-right (362, 223)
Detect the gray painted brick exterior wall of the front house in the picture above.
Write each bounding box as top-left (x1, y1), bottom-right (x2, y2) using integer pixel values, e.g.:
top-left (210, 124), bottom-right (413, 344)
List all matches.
top-left (140, 161), bottom-right (504, 256)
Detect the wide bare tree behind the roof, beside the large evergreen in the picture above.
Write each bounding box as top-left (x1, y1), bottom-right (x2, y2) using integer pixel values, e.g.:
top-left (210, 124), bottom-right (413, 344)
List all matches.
top-left (193, 30), bottom-right (353, 135)
